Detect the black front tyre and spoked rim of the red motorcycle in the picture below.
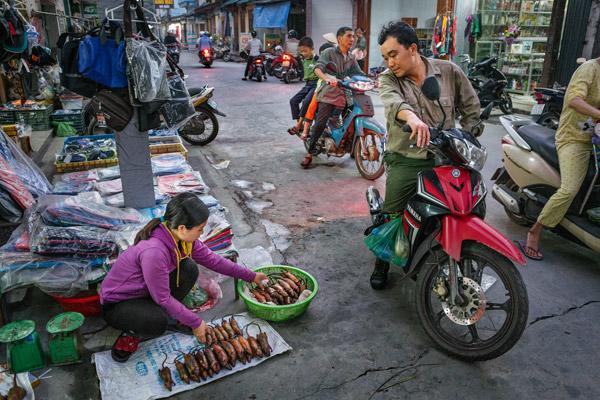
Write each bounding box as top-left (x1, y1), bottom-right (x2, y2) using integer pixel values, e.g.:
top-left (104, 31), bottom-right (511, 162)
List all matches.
top-left (415, 242), bottom-right (529, 361)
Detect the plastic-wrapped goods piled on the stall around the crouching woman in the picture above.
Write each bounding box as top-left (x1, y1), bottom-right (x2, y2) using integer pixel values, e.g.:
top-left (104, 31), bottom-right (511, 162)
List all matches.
top-left (0, 148), bottom-right (238, 310)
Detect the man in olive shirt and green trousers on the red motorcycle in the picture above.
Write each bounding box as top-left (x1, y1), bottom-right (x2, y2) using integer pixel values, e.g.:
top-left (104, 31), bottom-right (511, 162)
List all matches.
top-left (371, 21), bottom-right (481, 289)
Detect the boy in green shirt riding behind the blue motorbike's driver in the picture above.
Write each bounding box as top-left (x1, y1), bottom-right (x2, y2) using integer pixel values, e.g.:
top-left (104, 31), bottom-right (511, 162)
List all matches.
top-left (288, 37), bottom-right (319, 135)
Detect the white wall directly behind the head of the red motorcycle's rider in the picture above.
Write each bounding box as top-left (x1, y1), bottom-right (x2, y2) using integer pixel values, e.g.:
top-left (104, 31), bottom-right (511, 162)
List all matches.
top-left (369, 0), bottom-right (437, 68)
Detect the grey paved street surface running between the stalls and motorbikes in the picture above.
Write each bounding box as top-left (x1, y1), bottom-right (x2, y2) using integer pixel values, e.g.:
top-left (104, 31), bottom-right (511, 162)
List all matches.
top-left (168, 54), bottom-right (600, 399)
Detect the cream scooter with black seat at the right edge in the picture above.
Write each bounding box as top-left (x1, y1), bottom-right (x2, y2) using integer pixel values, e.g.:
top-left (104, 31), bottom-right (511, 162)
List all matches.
top-left (492, 117), bottom-right (600, 252)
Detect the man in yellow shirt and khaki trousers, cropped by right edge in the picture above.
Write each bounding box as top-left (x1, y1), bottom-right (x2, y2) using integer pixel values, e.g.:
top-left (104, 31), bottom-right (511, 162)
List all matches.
top-left (519, 58), bottom-right (600, 260)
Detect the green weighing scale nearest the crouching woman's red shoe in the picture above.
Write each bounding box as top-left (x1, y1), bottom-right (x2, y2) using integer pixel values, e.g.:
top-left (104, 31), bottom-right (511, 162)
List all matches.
top-left (46, 312), bottom-right (85, 365)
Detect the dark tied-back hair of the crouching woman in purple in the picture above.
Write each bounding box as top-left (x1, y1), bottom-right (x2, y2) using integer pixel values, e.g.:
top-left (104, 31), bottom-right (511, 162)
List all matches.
top-left (134, 193), bottom-right (210, 244)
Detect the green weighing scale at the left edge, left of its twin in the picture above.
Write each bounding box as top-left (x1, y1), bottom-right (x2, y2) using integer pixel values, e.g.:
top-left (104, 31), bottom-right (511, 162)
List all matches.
top-left (0, 320), bottom-right (46, 373)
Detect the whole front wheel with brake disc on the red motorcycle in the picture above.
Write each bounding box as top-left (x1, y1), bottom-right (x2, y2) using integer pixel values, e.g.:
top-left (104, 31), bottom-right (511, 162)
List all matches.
top-left (415, 242), bottom-right (529, 361)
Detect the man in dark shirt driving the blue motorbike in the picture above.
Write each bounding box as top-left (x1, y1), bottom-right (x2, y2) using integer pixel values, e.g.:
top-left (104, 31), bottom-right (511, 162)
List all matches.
top-left (300, 26), bottom-right (363, 168)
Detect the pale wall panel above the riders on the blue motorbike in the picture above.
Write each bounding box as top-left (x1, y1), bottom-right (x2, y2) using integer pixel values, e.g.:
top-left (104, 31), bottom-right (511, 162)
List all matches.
top-left (310, 0), bottom-right (354, 50)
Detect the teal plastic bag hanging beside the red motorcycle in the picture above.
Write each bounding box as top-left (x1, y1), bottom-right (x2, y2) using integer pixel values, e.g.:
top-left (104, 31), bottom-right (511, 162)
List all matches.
top-left (365, 218), bottom-right (409, 267)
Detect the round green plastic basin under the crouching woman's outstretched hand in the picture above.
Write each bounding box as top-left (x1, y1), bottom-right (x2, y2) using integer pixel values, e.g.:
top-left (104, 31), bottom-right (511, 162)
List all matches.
top-left (236, 265), bottom-right (319, 322)
